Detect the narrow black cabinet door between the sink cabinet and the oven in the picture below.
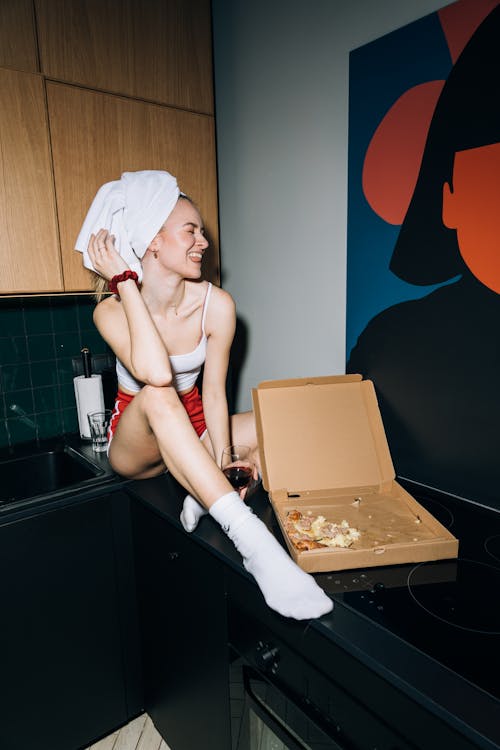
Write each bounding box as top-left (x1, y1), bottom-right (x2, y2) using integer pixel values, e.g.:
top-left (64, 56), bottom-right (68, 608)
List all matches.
top-left (133, 502), bottom-right (231, 750)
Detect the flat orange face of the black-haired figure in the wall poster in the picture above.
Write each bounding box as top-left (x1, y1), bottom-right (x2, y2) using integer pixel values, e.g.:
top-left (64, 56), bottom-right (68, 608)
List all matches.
top-left (443, 143), bottom-right (500, 294)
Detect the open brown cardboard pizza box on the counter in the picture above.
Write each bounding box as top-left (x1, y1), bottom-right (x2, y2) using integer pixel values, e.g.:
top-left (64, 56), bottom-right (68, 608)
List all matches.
top-left (252, 375), bottom-right (458, 573)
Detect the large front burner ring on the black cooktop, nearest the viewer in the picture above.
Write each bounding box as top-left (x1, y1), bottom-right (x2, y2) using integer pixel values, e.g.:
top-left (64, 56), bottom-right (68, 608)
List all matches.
top-left (407, 558), bottom-right (500, 636)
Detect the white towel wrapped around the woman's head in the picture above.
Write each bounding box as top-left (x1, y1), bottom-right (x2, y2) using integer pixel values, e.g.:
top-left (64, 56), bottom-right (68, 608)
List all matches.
top-left (75, 169), bottom-right (180, 279)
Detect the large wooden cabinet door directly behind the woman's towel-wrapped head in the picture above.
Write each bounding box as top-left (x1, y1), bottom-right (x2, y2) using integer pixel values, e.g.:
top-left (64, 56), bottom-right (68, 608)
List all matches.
top-left (47, 82), bottom-right (219, 291)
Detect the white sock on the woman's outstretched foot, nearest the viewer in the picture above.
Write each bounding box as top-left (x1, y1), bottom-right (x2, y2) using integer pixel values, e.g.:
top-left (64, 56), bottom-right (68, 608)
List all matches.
top-left (209, 492), bottom-right (333, 620)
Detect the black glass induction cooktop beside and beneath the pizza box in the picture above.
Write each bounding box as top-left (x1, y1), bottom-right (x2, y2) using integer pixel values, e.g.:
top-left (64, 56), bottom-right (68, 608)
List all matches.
top-left (317, 478), bottom-right (500, 699)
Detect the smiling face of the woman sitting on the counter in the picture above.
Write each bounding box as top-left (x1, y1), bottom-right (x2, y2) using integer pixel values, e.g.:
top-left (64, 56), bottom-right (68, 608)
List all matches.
top-left (150, 198), bottom-right (208, 278)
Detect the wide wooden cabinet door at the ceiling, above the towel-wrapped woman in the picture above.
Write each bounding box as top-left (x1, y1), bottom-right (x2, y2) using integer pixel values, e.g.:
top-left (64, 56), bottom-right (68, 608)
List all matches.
top-left (36, 0), bottom-right (213, 114)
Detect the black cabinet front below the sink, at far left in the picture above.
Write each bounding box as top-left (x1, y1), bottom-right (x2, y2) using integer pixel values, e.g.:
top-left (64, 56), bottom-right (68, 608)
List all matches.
top-left (0, 491), bottom-right (142, 750)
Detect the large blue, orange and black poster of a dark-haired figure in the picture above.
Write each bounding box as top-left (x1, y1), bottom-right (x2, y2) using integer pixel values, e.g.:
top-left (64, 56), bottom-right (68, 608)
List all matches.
top-left (346, 0), bottom-right (500, 507)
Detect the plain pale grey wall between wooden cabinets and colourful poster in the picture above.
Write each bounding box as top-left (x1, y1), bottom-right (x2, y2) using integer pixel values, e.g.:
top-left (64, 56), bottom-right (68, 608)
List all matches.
top-left (213, 0), bottom-right (446, 410)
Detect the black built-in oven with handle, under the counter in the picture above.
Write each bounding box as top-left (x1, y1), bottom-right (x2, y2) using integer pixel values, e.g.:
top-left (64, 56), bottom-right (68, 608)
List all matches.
top-left (229, 605), bottom-right (416, 750)
